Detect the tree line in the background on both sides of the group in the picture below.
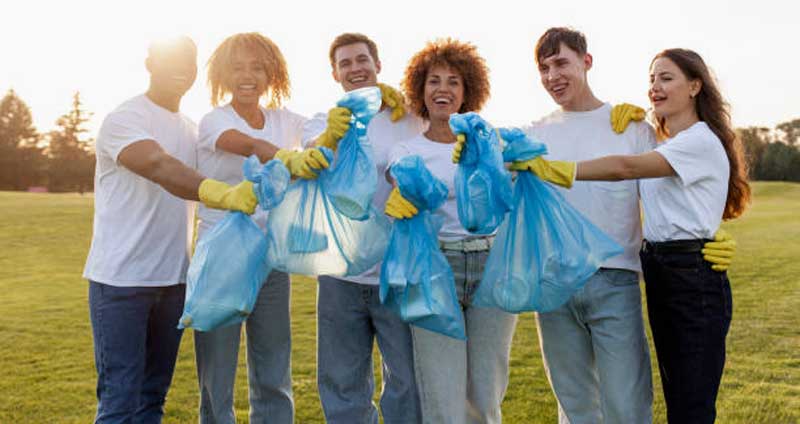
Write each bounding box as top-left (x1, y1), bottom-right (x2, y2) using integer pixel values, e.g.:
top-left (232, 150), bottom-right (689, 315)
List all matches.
top-left (0, 90), bottom-right (800, 193)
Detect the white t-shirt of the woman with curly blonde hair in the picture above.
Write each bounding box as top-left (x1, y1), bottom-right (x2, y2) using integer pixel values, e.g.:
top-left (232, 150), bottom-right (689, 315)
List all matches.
top-left (197, 104), bottom-right (306, 237)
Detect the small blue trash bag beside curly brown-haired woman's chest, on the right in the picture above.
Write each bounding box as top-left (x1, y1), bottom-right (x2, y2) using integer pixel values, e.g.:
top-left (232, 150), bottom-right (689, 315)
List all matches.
top-left (450, 112), bottom-right (511, 234)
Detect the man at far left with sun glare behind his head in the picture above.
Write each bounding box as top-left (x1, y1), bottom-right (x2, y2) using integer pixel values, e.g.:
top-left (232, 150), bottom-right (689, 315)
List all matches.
top-left (83, 37), bottom-right (257, 423)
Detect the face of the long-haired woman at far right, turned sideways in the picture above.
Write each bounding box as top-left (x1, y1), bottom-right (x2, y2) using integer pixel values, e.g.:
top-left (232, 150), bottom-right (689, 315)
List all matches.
top-left (647, 57), bottom-right (702, 118)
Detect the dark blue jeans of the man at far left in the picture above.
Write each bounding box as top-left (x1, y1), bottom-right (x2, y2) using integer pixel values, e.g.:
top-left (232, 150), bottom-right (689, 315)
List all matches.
top-left (89, 281), bottom-right (186, 423)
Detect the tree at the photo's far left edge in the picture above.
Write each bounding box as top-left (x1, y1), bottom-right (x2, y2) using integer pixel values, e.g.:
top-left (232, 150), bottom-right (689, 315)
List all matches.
top-left (0, 90), bottom-right (45, 190)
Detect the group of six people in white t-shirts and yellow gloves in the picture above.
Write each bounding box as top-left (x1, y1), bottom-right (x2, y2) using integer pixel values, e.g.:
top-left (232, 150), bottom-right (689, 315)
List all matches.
top-left (84, 28), bottom-right (750, 424)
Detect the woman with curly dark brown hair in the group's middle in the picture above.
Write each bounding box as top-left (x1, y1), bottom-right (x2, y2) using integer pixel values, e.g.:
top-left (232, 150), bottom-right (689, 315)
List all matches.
top-left (386, 39), bottom-right (516, 424)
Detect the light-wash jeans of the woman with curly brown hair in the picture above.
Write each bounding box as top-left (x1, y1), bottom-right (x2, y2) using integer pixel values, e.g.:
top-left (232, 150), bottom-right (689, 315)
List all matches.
top-left (411, 250), bottom-right (517, 424)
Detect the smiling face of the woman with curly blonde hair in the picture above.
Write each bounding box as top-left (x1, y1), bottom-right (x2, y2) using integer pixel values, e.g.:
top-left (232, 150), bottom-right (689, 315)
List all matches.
top-left (225, 48), bottom-right (268, 105)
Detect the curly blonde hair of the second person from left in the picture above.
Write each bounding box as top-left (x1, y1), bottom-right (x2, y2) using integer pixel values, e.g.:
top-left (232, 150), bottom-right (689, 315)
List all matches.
top-left (208, 32), bottom-right (291, 108)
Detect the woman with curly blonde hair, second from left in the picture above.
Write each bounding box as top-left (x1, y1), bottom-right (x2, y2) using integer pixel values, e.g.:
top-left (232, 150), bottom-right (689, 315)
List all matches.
top-left (194, 33), bottom-right (327, 423)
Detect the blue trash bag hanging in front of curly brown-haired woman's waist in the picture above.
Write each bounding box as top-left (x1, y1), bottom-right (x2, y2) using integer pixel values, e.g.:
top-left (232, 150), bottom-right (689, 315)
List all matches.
top-left (380, 155), bottom-right (466, 340)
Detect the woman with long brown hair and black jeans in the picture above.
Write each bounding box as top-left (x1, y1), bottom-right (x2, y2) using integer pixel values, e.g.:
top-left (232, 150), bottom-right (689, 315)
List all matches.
top-left (512, 49), bottom-right (750, 423)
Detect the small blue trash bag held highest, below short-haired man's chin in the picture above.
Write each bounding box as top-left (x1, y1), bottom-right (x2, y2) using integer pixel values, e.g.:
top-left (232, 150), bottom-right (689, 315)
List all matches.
top-left (325, 87), bottom-right (383, 219)
